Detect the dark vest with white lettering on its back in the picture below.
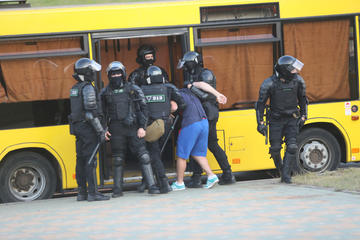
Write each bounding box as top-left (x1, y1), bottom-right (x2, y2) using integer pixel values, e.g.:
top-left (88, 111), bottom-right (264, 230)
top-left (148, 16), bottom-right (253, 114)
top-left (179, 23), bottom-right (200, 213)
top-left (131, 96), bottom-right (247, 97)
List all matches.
top-left (141, 84), bottom-right (171, 120)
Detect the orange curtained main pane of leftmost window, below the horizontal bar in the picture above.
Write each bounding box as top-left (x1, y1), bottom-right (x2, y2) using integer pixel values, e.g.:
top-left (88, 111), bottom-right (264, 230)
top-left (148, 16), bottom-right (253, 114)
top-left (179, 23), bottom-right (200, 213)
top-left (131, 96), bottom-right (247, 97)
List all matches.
top-left (0, 56), bottom-right (81, 102)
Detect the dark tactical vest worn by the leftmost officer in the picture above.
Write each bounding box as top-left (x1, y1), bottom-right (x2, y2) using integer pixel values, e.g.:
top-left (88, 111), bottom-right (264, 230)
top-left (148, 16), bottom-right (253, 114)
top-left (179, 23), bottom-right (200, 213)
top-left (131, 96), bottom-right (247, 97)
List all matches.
top-left (70, 82), bottom-right (102, 123)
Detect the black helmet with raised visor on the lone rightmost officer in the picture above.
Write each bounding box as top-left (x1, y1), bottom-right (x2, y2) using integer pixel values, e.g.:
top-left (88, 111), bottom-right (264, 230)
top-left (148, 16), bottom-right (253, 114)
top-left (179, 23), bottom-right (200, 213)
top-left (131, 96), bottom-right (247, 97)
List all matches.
top-left (275, 55), bottom-right (304, 81)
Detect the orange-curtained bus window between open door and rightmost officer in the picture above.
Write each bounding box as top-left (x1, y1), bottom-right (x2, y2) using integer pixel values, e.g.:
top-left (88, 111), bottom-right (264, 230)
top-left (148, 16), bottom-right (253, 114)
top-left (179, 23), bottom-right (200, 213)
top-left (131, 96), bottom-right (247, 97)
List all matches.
top-left (197, 24), bottom-right (279, 109)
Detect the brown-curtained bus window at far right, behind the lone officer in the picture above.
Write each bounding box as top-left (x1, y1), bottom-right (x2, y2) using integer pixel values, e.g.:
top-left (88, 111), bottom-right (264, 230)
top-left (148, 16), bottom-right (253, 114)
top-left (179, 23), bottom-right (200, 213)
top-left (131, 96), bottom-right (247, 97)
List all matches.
top-left (284, 19), bottom-right (358, 102)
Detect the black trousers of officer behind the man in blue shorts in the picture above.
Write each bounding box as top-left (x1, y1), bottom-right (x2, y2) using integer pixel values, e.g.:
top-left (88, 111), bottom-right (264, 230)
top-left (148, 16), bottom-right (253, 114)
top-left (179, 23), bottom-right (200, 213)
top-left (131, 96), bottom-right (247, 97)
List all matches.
top-left (191, 118), bottom-right (231, 174)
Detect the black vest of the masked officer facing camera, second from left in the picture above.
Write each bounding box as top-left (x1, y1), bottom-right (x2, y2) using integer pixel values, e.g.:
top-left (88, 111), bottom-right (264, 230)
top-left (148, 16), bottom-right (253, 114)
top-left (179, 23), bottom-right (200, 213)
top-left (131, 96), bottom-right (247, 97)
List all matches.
top-left (105, 87), bottom-right (131, 120)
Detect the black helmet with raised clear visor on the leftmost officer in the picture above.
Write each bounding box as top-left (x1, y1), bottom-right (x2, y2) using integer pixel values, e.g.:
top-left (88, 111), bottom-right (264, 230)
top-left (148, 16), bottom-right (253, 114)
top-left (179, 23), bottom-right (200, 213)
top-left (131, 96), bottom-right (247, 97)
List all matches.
top-left (73, 58), bottom-right (101, 82)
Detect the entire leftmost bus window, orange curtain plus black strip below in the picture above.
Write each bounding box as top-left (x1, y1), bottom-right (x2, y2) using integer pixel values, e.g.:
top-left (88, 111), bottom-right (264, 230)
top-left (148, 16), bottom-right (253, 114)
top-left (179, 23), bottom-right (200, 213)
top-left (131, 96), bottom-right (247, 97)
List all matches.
top-left (0, 37), bottom-right (86, 129)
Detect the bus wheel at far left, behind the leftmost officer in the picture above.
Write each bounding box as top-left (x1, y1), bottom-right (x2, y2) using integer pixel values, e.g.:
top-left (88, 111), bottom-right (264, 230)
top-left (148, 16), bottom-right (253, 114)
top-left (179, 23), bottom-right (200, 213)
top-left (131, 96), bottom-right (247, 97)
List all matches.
top-left (0, 152), bottom-right (56, 202)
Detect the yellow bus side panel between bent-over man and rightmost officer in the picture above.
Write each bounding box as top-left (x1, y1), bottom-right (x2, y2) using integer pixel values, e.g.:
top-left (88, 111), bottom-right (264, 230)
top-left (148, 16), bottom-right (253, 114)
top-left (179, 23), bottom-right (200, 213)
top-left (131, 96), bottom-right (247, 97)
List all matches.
top-left (207, 109), bottom-right (275, 172)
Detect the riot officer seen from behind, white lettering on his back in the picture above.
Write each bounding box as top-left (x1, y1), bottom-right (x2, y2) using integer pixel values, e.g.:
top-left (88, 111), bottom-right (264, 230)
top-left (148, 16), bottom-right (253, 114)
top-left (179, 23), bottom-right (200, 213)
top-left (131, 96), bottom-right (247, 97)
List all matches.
top-left (141, 66), bottom-right (185, 193)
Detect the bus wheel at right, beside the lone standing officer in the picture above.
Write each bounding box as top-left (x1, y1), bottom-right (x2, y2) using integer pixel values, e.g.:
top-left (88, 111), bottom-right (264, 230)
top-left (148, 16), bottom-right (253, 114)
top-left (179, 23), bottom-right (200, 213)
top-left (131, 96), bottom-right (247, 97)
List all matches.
top-left (294, 128), bottom-right (341, 173)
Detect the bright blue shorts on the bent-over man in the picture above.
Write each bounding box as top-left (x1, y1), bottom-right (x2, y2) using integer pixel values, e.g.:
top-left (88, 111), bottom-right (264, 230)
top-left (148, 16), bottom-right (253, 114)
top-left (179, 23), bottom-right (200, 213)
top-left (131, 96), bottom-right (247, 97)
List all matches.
top-left (176, 119), bottom-right (209, 159)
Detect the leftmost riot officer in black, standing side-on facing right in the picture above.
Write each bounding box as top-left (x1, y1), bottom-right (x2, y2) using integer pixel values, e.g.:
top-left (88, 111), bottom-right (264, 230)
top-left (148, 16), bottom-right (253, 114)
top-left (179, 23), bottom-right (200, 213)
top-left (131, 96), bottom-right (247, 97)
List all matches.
top-left (69, 58), bottom-right (109, 201)
